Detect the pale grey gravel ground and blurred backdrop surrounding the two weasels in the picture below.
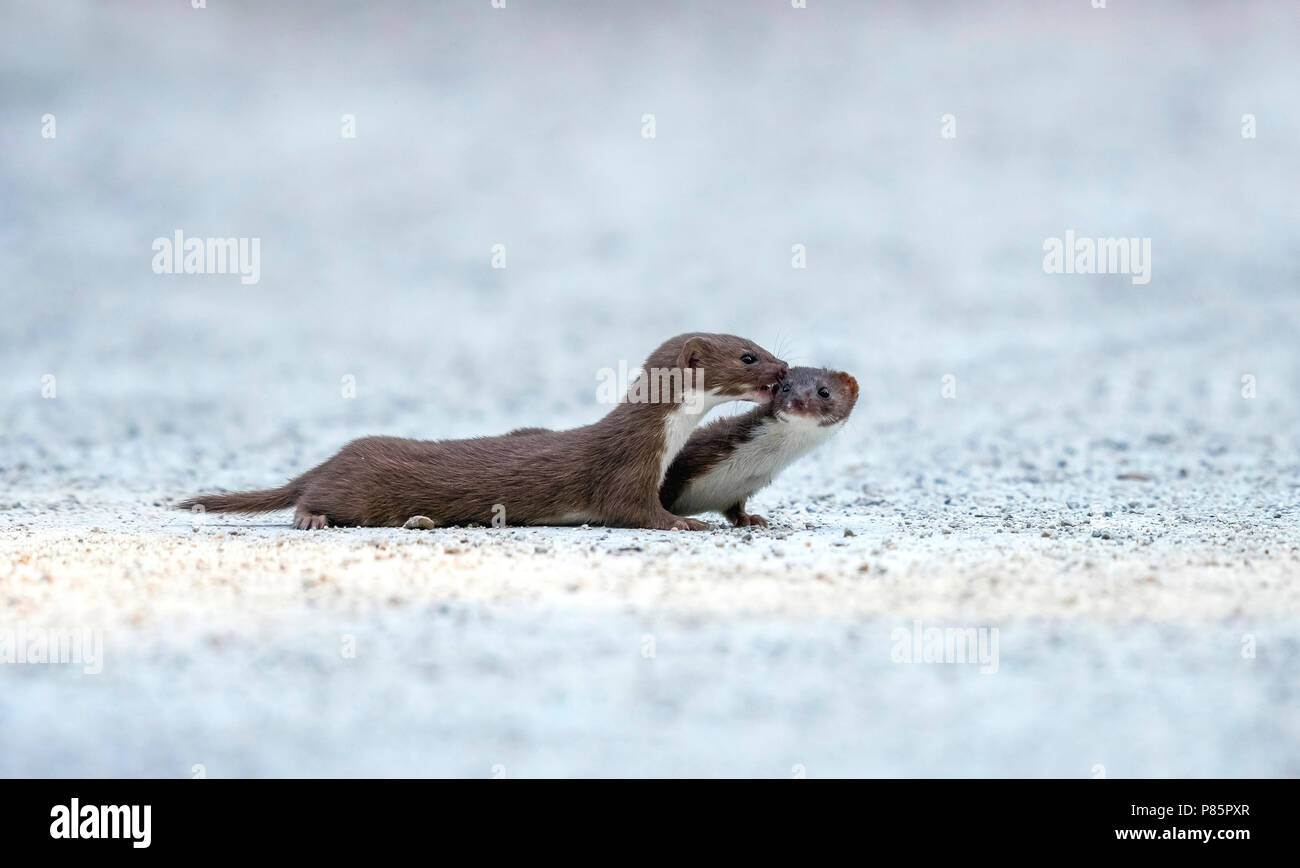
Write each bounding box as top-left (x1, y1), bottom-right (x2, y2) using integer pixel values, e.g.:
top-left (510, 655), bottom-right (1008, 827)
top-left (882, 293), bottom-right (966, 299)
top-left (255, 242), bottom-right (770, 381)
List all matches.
top-left (0, 3), bottom-right (1300, 777)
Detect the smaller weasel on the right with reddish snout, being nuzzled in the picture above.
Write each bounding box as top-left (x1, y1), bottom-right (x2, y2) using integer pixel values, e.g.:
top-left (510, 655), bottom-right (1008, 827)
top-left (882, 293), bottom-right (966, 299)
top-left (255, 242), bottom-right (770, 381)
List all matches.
top-left (659, 368), bottom-right (858, 528)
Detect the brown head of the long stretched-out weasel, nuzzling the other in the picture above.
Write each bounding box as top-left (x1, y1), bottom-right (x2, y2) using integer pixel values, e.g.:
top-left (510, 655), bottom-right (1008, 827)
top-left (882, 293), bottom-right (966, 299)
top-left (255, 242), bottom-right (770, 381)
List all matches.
top-left (646, 333), bottom-right (789, 404)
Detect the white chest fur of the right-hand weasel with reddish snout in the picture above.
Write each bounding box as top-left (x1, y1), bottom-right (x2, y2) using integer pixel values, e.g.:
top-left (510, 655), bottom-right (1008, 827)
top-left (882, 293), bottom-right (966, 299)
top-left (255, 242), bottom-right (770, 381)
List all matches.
top-left (672, 416), bottom-right (844, 515)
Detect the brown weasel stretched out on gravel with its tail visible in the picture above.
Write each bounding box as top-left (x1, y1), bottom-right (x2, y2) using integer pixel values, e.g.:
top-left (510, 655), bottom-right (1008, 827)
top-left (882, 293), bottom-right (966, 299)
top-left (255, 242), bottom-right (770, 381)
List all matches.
top-left (179, 334), bottom-right (787, 530)
